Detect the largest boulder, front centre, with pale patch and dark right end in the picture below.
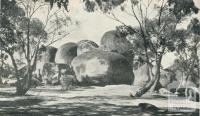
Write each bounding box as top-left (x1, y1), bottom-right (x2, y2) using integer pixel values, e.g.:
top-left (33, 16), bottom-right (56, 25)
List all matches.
top-left (72, 50), bottom-right (134, 86)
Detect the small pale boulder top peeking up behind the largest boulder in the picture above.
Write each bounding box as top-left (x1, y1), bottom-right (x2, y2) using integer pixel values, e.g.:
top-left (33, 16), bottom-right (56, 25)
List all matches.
top-left (77, 40), bottom-right (99, 55)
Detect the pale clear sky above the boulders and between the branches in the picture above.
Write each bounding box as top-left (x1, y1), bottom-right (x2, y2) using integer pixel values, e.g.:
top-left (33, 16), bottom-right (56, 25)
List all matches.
top-left (18, 0), bottom-right (200, 67)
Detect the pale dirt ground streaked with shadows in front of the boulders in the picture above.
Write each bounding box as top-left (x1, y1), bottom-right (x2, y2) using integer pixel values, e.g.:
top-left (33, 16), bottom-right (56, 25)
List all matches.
top-left (0, 85), bottom-right (200, 116)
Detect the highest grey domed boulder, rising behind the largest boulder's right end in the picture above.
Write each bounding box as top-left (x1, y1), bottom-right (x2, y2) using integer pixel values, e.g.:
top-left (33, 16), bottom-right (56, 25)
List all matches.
top-left (100, 30), bottom-right (133, 63)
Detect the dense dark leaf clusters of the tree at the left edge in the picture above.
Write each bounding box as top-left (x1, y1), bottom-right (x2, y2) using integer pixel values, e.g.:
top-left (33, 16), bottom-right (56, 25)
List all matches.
top-left (0, 0), bottom-right (47, 53)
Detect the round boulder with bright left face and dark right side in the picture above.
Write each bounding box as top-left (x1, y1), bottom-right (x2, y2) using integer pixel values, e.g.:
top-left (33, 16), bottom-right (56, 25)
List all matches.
top-left (55, 42), bottom-right (77, 65)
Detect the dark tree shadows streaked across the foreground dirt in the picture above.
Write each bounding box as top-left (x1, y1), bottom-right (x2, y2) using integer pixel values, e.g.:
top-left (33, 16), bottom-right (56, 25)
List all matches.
top-left (0, 96), bottom-right (198, 116)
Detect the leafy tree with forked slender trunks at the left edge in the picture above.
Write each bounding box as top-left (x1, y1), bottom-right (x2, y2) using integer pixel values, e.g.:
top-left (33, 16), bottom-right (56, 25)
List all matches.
top-left (0, 0), bottom-right (46, 95)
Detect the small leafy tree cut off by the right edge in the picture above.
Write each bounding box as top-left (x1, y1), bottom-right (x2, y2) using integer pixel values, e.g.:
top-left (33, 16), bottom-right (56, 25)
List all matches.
top-left (176, 18), bottom-right (200, 87)
